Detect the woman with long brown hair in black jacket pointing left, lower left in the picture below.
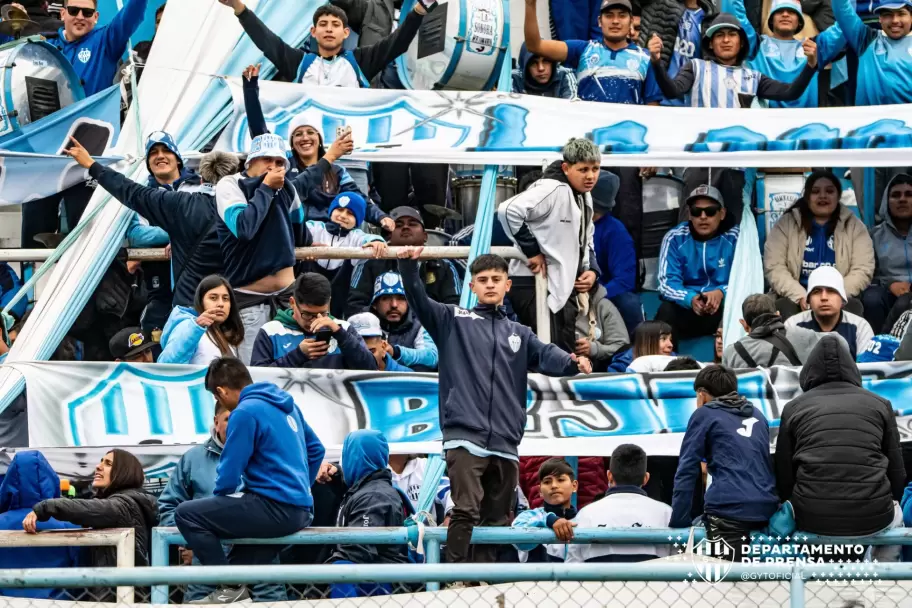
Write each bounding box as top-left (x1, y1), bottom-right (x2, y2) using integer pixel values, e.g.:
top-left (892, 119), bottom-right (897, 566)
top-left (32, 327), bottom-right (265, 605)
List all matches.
top-left (22, 448), bottom-right (158, 568)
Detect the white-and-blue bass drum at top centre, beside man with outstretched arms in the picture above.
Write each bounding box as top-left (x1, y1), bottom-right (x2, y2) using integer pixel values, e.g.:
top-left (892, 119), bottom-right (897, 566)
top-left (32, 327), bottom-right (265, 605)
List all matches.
top-left (396, 0), bottom-right (510, 91)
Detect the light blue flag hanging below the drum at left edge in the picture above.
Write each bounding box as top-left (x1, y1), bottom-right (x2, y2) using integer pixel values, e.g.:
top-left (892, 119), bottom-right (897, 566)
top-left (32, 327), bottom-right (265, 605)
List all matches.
top-left (0, 86), bottom-right (120, 205)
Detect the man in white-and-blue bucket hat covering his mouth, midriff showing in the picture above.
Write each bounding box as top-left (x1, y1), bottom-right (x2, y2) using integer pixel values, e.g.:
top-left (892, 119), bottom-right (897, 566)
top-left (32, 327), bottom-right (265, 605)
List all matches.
top-left (215, 133), bottom-right (312, 362)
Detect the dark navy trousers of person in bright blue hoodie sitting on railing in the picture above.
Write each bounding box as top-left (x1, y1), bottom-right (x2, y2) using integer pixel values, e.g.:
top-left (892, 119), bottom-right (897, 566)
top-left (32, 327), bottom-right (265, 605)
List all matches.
top-left (174, 493), bottom-right (313, 566)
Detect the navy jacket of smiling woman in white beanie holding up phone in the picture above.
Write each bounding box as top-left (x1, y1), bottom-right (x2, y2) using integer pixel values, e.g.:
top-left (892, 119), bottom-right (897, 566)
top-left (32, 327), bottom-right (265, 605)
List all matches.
top-left (243, 78), bottom-right (389, 226)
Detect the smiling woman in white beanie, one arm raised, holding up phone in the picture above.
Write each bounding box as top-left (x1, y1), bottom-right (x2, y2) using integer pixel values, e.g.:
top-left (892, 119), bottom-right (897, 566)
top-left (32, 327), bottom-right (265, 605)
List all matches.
top-left (242, 65), bottom-right (396, 232)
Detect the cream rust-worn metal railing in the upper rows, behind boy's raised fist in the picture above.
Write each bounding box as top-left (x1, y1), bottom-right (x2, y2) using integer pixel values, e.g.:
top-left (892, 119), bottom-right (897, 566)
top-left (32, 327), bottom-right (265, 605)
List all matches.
top-left (0, 247), bottom-right (551, 344)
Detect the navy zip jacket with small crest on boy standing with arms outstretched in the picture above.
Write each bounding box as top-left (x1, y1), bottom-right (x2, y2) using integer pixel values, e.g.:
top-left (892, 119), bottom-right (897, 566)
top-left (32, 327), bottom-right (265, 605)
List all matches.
top-left (399, 260), bottom-right (579, 454)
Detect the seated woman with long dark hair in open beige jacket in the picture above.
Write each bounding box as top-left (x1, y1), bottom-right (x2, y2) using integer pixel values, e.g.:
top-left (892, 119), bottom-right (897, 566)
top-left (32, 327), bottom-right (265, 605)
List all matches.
top-left (763, 170), bottom-right (874, 319)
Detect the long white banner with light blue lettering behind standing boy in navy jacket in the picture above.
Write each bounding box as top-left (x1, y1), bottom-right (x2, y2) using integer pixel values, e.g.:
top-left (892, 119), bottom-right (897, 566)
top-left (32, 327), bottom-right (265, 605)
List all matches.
top-left (13, 362), bottom-right (912, 478)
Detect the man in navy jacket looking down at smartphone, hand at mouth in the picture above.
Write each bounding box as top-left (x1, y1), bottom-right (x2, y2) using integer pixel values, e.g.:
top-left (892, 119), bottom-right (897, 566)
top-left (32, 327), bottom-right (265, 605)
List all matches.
top-left (250, 272), bottom-right (377, 370)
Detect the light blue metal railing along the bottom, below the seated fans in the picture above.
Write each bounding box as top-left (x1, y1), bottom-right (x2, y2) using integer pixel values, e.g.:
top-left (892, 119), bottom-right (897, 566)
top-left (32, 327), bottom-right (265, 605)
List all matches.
top-left (150, 526), bottom-right (912, 604)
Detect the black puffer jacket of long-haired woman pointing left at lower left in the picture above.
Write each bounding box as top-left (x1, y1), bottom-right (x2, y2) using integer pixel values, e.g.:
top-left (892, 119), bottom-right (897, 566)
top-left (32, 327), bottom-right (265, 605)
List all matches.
top-left (33, 489), bottom-right (158, 568)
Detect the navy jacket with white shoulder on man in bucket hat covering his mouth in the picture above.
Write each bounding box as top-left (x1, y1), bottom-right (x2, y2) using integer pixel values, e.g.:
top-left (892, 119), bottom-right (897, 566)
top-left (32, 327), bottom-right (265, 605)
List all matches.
top-left (215, 173), bottom-right (312, 287)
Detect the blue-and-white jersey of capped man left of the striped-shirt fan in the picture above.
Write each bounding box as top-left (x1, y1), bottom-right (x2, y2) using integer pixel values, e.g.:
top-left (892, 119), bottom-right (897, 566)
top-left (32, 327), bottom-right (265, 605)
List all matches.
top-left (564, 40), bottom-right (662, 105)
